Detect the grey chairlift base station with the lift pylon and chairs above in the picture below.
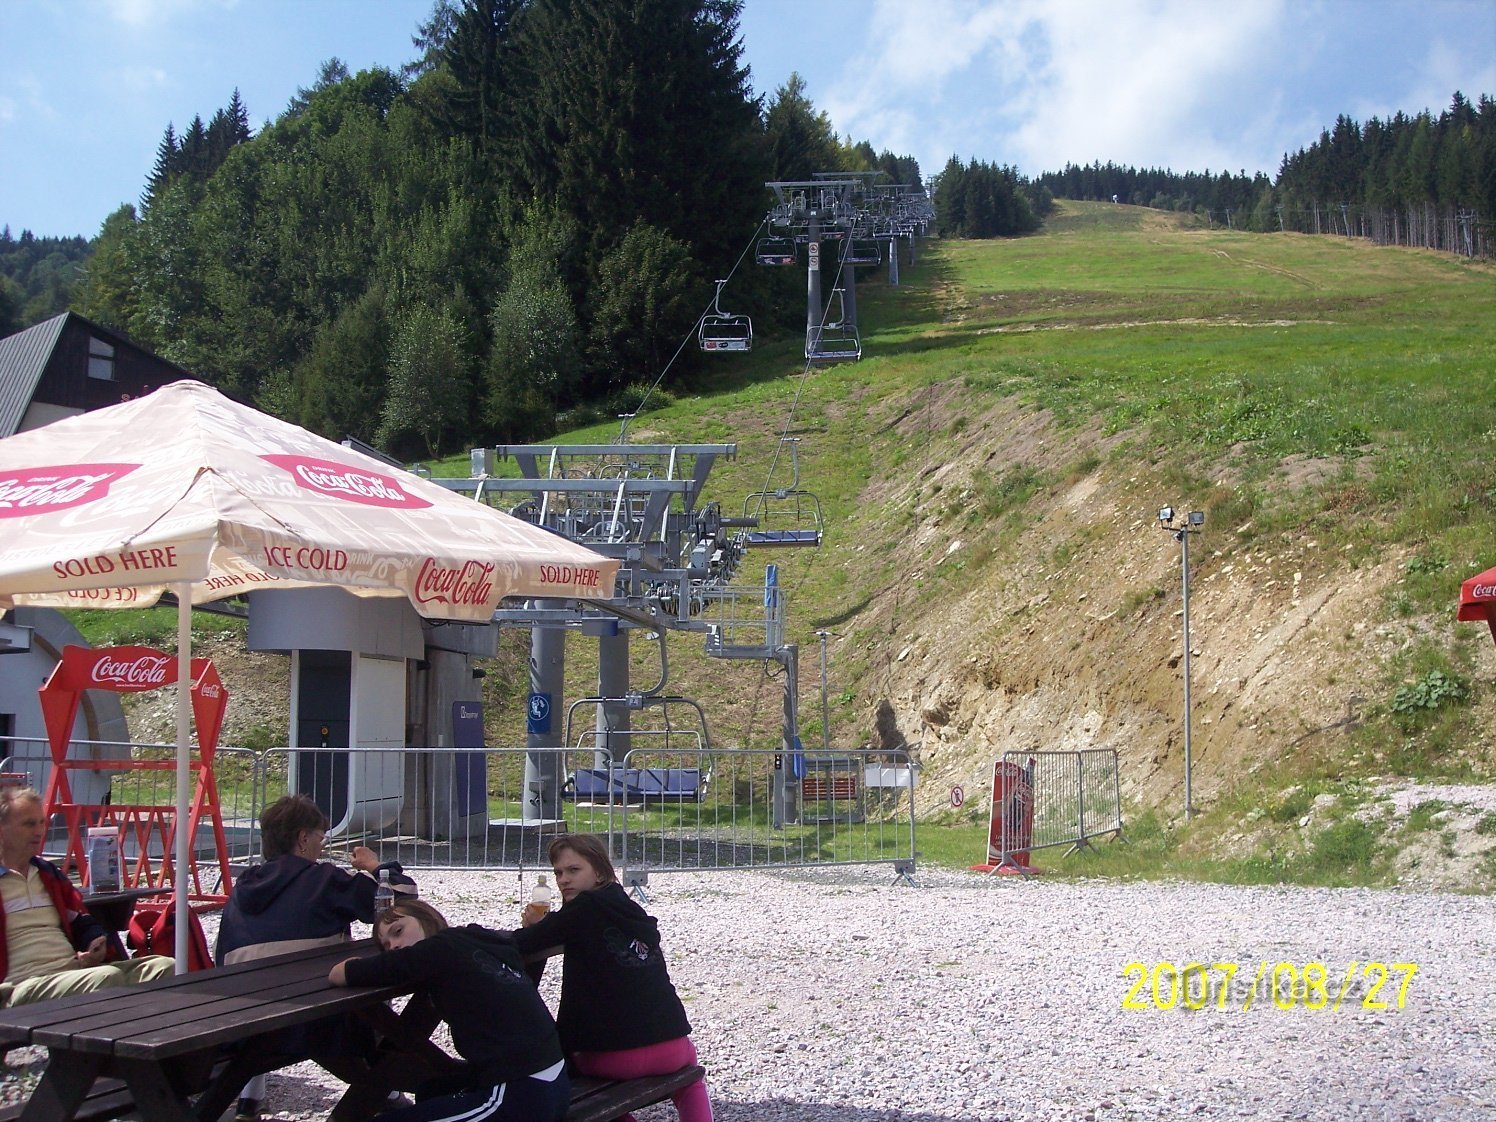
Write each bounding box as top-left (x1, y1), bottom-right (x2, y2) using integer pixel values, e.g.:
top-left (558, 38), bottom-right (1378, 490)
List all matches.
top-left (234, 172), bottom-right (934, 836)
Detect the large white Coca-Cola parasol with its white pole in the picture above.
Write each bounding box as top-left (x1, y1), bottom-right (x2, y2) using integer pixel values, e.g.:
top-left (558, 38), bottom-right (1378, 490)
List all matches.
top-left (0, 381), bottom-right (618, 969)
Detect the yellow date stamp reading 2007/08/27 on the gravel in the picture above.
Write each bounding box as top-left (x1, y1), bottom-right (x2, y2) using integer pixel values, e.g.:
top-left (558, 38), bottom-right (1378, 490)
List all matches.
top-left (1122, 959), bottom-right (1418, 1013)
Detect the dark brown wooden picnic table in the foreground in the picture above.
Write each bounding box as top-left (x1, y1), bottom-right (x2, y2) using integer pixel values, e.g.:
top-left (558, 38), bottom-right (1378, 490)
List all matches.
top-left (0, 939), bottom-right (450, 1122)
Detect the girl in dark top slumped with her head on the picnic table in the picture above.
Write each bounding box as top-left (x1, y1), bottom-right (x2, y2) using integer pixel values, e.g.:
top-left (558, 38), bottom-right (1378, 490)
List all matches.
top-left (328, 901), bottom-right (571, 1122)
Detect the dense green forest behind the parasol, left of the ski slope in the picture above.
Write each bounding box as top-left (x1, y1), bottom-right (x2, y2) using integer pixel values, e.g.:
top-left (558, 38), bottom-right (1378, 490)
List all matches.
top-left (17, 0), bottom-right (920, 456)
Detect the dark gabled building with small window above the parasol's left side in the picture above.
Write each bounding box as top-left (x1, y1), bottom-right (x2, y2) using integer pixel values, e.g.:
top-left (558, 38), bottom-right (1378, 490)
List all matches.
top-left (0, 311), bottom-right (193, 437)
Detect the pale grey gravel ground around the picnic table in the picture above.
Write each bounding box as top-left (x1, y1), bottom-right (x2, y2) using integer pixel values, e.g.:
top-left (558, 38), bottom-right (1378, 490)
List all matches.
top-left (6, 868), bottom-right (1496, 1122)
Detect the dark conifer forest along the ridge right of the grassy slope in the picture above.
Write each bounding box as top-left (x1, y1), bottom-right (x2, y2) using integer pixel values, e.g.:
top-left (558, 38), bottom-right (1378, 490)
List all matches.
top-left (1037, 91), bottom-right (1496, 256)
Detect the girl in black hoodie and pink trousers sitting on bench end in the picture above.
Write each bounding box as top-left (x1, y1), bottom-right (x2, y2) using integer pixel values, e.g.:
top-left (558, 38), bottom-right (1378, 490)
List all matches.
top-left (513, 833), bottom-right (712, 1122)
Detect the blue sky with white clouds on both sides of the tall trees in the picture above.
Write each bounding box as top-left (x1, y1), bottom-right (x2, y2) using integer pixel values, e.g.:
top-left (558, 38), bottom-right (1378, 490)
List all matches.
top-left (0, 0), bottom-right (1496, 236)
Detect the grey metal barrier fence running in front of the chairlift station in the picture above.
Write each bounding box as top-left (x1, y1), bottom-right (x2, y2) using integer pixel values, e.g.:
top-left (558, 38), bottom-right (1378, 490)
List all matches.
top-left (0, 742), bottom-right (916, 886)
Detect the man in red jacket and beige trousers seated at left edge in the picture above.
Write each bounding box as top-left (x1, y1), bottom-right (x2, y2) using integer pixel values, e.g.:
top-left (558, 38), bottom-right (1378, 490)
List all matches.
top-left (0, 787), bottom-right (174, 1007)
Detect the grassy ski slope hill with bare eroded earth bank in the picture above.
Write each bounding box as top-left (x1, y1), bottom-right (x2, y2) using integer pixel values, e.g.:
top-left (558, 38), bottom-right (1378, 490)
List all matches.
top-left (105, 203), bottom-right (1496, 884)
